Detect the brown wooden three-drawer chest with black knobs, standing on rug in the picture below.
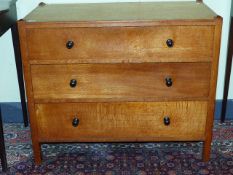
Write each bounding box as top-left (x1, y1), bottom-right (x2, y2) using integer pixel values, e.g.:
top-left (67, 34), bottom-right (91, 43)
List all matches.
top-left (18, 2), bottom-right (222, 163)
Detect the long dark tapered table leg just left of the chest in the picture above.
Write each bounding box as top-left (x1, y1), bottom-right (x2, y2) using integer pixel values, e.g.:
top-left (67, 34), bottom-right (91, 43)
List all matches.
top-left (11, 24), bottom-right (28, 127)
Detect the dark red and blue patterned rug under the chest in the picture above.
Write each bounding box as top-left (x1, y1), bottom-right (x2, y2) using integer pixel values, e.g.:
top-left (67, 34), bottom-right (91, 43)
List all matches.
top-left (0, 121), bottom-right (233, 175)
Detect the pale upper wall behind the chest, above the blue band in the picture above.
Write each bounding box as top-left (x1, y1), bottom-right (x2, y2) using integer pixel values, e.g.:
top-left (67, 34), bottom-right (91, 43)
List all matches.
top-left (0, 0), bottom-right (233, 102)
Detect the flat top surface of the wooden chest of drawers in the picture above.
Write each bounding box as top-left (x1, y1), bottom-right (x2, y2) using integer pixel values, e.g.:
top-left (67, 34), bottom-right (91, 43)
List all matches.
top-left (25, 2), bottom-right (217, 22)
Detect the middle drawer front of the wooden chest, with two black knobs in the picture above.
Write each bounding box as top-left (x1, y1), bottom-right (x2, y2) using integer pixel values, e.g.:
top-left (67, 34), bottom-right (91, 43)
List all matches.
top-left (31, 63), bottom-right (210, 102)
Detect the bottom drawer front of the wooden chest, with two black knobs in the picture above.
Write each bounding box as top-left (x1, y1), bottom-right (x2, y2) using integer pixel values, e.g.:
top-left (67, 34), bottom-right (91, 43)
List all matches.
top-left (35, 101), bottom-right (207, 142)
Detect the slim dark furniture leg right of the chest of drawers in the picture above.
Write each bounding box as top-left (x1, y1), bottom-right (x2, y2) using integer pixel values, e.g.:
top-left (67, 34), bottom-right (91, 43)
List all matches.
top-left (221, 17), bottom-right (233, 122)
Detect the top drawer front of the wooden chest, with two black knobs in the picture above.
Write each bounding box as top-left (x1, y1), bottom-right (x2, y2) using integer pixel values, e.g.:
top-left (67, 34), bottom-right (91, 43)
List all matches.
top-left (27, 26), bottom-right (214, 63)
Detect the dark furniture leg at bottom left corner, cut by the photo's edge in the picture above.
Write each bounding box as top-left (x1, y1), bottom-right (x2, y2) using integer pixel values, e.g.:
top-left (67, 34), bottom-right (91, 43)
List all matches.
top-left (0, 107), bottom-right (7, 172)
